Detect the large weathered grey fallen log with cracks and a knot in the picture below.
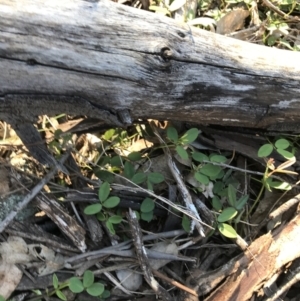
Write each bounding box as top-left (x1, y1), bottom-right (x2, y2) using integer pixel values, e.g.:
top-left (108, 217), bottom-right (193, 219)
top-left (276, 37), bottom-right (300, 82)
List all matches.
top-left (0, 0), bottom-right (300, 131)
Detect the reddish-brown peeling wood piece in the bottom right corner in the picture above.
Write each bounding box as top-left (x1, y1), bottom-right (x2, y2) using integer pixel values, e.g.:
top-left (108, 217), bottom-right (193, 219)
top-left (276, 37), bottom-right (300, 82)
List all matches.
top-left (189, 211), bottom-right (300, 301)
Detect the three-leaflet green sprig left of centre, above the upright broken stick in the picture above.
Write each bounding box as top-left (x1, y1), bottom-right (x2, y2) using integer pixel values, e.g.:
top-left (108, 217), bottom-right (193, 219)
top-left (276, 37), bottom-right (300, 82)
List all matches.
top-left (84, 182), bottom-right (122, 234)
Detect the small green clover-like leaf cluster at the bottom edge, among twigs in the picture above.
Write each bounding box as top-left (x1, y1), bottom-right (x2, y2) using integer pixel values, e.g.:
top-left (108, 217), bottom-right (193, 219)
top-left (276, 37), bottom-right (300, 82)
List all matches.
top-left (68, 270), bottom-right (110, 299)
